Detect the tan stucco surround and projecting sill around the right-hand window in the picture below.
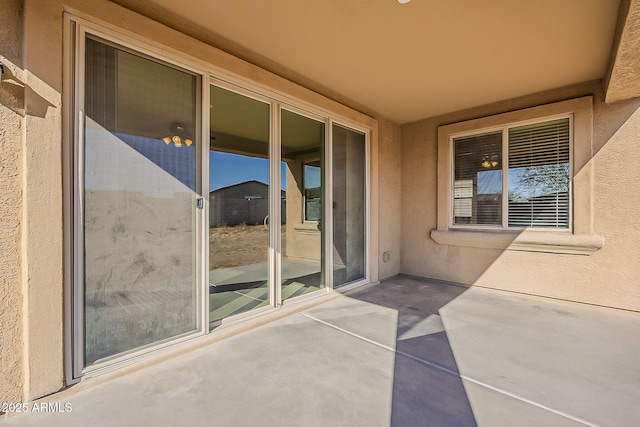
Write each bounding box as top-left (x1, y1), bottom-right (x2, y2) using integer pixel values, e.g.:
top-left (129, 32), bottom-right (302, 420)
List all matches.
top-left (430, 96), bottom-right (604, 255)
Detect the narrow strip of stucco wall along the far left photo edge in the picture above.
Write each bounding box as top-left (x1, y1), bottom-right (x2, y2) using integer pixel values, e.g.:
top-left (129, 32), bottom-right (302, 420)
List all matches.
top-left (0, 0), bottom-right (24, 403)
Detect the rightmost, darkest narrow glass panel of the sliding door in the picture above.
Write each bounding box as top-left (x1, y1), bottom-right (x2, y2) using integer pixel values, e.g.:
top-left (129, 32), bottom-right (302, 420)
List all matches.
top-left (332, 125), bottom-right (367, 287)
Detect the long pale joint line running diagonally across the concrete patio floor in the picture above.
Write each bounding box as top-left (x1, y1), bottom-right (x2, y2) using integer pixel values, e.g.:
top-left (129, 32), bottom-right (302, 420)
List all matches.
top-left (302, 312), bottom-right (599, 427)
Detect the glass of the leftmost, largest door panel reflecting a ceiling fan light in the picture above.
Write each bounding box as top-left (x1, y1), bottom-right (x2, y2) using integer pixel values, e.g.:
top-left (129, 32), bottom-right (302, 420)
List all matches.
top-left (80, 38), bottom-right (200, 366)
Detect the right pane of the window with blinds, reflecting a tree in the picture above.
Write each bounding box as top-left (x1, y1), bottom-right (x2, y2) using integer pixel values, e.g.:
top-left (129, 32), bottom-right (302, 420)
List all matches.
top-left (508, 118), bottom-right (570, 228)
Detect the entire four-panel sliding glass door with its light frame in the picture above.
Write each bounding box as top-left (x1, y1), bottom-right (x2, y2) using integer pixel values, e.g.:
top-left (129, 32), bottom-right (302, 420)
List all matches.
top-left (70, 24), bottom-right (368, 377)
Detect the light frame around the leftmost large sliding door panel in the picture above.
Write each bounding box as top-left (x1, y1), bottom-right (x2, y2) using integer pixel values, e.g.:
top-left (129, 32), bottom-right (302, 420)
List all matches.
top-left (65, 15), bottom-right (209, 383)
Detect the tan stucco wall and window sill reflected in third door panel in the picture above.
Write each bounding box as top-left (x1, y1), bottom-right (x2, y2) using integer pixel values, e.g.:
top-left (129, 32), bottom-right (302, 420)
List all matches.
top-left (283, 158), bottom-right (322, 261)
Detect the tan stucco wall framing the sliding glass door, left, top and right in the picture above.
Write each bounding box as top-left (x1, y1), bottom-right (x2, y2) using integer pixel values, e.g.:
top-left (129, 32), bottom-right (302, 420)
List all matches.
top-left (0, 0), bottom-right (390, 401)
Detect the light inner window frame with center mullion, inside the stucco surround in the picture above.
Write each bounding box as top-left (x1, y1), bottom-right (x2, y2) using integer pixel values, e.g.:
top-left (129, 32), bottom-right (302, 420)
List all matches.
top-left (449, 113), bottom-right (574, 233)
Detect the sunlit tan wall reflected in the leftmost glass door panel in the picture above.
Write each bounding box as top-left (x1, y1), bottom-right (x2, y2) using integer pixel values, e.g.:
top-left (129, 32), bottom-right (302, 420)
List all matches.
top-left (84, 123), bottom-right (195, 363)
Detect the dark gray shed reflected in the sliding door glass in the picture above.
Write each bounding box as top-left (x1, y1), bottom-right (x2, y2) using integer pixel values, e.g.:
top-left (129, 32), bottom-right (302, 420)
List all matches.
top-left (209, 180), bottom-right (285, 227)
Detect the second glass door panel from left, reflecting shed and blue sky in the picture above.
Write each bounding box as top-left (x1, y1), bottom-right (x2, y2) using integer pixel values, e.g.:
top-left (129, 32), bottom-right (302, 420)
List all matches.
top-left (209, 86), bottom-right (270, 322)
